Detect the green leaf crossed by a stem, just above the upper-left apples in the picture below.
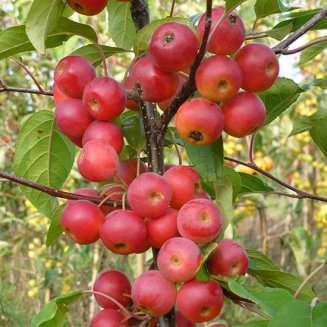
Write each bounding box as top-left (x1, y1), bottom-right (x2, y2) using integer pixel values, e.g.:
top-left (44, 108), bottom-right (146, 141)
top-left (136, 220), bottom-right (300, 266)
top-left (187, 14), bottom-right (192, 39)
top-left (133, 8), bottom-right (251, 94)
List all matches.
top-left (71, 44), bottom-right (129, 67)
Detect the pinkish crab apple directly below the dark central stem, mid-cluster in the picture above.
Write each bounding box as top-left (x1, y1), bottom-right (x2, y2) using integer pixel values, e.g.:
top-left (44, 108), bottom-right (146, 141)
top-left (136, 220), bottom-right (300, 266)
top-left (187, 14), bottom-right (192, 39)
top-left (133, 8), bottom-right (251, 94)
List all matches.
top-left (127, 172), bottom-right (172, 219)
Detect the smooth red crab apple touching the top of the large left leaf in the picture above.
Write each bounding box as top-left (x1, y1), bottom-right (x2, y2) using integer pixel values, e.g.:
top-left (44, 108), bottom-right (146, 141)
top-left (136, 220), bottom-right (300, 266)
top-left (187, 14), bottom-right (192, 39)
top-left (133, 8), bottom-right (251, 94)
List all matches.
top-left (55, 99), bottom-right (93, 139)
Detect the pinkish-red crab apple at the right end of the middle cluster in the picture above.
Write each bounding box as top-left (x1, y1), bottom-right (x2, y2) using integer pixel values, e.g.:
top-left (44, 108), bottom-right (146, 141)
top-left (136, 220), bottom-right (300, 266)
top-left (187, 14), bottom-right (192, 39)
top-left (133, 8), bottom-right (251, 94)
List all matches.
top-left (177, 198), bottom-right (222, 243)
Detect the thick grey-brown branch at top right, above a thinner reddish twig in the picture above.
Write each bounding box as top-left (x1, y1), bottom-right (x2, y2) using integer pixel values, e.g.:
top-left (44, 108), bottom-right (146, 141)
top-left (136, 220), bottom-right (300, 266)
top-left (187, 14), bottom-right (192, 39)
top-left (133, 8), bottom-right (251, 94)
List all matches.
top-left (272, 7), bottom-right (327, 54)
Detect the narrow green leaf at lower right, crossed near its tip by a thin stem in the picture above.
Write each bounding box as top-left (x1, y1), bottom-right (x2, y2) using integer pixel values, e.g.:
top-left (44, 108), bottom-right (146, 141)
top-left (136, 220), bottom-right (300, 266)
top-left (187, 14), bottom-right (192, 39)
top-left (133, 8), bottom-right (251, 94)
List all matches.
top-left (248, 269), bottom-right (315, 302)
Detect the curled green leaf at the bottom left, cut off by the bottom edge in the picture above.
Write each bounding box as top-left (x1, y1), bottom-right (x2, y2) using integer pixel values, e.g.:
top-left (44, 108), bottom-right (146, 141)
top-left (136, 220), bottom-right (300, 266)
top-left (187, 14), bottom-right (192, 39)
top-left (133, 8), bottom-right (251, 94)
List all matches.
top-left (30, 291), bottom-right (83, 327)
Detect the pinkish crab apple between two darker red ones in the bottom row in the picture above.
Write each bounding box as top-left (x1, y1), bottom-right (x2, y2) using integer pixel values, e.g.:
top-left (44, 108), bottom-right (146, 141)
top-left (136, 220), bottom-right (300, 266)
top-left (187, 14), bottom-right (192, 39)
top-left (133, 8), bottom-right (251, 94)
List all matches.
top-left (132, 270), bottom-right (176, 317)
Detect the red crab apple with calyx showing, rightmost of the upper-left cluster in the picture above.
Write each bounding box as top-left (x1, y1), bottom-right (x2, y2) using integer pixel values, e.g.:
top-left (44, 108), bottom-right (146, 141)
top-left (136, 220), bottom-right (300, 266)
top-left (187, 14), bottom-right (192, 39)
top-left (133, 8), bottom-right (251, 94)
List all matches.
top-left (83, 77), bottom-right (127, 120)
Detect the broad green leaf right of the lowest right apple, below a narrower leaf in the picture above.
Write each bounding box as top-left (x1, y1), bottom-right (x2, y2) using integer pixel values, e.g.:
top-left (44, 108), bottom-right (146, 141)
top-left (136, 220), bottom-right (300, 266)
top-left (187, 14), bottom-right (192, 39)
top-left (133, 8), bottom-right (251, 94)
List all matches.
top-left (228, 279), bottom-right (293, 317)
